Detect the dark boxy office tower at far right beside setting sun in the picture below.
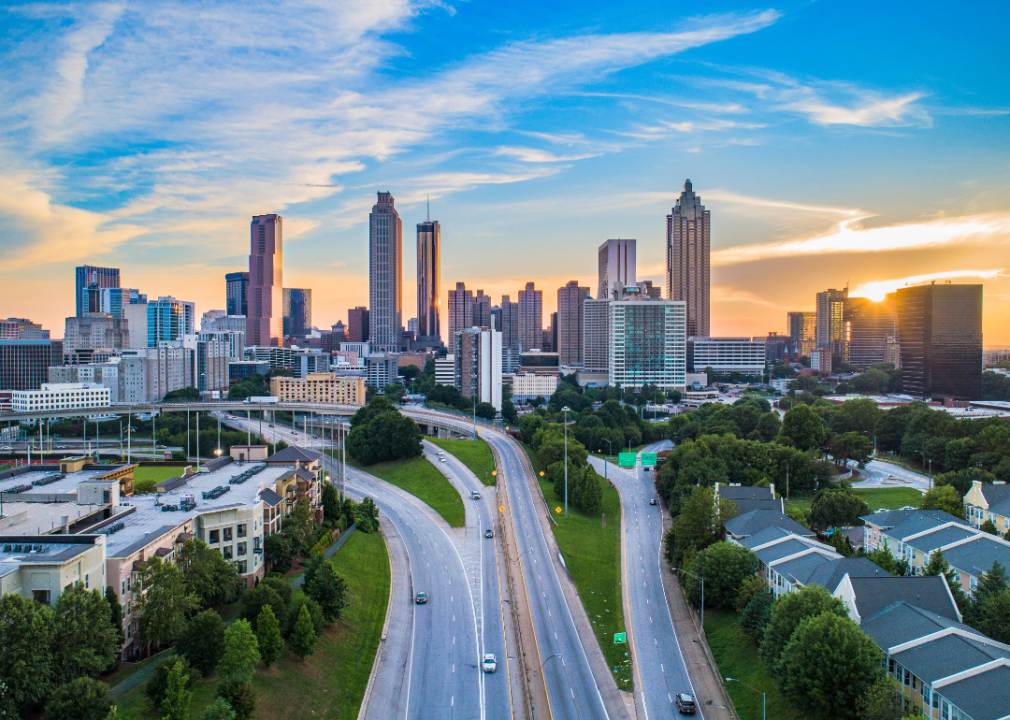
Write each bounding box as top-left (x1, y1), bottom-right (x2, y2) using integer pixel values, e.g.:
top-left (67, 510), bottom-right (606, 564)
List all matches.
top-left (897, 285), bottom-right (982, 400)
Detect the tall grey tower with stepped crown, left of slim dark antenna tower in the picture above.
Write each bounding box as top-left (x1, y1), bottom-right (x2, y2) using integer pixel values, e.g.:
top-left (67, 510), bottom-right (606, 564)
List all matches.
top-left (369, 193), bottom-right (403, 352)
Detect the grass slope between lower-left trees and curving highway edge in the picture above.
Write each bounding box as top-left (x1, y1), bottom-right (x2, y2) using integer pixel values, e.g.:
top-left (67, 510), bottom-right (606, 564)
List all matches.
top-left (118, 532), bottom-right (390, 720)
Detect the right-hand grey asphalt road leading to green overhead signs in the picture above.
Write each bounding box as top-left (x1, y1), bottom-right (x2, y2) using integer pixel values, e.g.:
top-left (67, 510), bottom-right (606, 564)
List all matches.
top-left (591, 440), bottom-right (698, 720)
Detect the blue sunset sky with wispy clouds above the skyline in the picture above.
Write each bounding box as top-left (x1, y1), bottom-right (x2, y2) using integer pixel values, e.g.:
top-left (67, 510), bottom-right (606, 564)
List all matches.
top-left (0, 0), bottom-right (1010, 346)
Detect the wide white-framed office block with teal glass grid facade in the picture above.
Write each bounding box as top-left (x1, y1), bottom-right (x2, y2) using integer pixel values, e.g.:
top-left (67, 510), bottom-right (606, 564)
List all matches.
top-left (607, 283), bottom-right (687, 390)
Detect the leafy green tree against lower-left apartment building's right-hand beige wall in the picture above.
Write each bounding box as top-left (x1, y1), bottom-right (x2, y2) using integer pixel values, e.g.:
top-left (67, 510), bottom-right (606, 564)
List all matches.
top-left (136, 557), bottom-right (200, 644)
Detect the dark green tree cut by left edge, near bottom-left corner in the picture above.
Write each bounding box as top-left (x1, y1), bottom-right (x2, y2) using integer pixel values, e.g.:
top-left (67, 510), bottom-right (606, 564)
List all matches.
top-left (0, 593), bottom-right (54, 713)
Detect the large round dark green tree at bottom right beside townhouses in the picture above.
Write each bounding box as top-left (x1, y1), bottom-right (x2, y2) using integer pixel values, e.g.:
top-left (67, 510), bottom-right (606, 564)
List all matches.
top-left (766, 612), bottom-right (884, 720)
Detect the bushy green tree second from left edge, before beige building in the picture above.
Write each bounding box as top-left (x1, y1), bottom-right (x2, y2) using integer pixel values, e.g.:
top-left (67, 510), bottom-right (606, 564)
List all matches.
top-left (53, 584), bottom-right (119, 685)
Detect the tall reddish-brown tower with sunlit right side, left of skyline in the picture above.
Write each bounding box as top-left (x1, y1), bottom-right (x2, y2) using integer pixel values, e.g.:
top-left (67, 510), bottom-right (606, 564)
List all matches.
top-left (248, 214), bottom-right (284, 346)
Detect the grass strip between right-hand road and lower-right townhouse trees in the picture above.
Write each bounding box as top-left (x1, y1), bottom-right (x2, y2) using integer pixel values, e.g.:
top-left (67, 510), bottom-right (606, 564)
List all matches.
top-left (705, 608), bottom-right (806, 720)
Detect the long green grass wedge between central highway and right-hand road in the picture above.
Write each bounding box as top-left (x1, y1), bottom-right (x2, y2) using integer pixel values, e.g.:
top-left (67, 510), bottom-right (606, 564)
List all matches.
top-left (526, 440), bottom-right (631, 690)
